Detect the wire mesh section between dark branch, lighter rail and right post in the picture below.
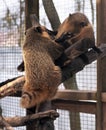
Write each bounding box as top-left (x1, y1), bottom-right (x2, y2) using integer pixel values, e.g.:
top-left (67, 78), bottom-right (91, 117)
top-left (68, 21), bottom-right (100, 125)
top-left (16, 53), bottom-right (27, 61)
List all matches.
top-left (76, 62), bottom-right (97, 90)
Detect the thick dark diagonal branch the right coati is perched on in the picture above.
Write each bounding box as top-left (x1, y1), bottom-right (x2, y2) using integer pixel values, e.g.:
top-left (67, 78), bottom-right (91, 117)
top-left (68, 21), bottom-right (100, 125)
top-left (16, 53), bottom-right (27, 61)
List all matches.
top-left (62, 44), bottom-right (106, 82)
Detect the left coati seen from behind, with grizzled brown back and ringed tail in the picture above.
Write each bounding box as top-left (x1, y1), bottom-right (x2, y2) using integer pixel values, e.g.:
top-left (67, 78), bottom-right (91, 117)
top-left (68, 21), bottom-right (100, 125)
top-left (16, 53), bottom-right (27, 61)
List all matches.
top-left (21, 26), bottom-right (64, 108)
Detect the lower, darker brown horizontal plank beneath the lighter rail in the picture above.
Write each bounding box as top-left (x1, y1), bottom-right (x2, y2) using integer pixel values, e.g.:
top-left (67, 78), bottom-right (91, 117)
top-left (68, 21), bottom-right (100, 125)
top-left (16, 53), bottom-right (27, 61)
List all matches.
top-left (52, 99), bottom-right (96, 114)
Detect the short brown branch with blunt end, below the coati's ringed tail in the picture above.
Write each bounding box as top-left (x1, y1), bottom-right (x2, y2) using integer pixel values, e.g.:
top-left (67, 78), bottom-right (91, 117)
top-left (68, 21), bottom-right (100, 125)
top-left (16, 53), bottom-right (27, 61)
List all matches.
top-left (0, 110), bottom-right (59, 127)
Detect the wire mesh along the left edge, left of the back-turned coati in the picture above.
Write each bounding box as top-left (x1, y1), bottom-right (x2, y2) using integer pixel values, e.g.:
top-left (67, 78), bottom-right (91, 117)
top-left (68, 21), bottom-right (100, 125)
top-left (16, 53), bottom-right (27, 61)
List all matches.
top-left (0, 0), bottom-right (26, 130)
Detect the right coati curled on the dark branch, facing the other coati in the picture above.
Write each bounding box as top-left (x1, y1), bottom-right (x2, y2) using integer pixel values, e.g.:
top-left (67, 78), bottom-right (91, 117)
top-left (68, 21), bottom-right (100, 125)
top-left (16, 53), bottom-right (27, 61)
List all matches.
top-left (55, 12), bottom-right (101, 65)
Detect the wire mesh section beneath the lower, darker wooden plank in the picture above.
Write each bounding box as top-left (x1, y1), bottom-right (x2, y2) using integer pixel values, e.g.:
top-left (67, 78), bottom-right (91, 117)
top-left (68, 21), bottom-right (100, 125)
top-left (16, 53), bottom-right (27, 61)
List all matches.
top-left (55, 110), bottom-right (95, 130)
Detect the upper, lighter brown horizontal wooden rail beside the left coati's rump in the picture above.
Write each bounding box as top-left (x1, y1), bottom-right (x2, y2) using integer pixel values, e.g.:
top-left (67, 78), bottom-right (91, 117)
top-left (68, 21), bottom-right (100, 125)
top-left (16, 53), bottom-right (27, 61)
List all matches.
top-left (53, 90), bottom-right (96, 101)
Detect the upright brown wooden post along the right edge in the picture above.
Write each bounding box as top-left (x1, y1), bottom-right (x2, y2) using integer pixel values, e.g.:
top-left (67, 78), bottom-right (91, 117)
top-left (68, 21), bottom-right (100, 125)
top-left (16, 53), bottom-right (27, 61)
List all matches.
top-left (96, 0), bottom-right (106, 130)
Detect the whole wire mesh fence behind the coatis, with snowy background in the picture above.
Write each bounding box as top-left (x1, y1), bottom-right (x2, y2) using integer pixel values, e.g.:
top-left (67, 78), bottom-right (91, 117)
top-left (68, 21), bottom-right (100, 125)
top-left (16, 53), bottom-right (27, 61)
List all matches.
top-left (0, 0), bottom-right (97, 130)
